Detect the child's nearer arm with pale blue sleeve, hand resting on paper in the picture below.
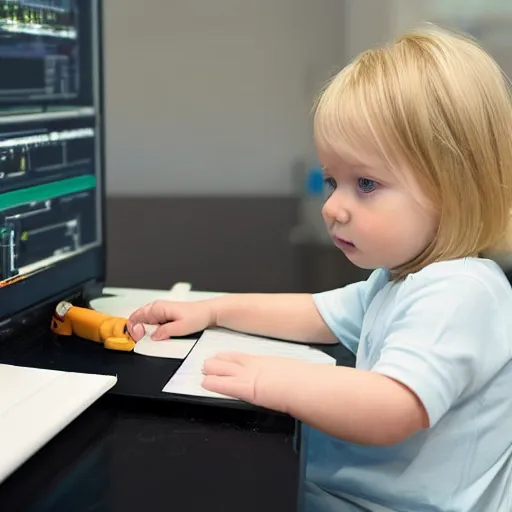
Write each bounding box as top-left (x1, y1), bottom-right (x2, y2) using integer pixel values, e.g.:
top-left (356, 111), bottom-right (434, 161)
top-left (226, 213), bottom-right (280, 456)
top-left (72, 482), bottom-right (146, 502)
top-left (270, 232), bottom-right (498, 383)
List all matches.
top-left (203, 274), bottom-right (500, 445)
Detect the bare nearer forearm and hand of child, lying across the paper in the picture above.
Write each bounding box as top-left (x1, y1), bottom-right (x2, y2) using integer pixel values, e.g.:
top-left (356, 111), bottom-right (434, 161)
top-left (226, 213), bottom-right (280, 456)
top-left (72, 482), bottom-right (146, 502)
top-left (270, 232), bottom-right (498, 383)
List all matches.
top-left (203, 353), bottom-right (429, 446)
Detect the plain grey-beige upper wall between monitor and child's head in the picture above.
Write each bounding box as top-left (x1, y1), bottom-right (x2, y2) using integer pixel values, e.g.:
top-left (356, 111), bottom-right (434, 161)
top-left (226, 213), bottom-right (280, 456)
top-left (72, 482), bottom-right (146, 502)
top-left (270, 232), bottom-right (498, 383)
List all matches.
top-left (104, 0), bottom-right (346, 196)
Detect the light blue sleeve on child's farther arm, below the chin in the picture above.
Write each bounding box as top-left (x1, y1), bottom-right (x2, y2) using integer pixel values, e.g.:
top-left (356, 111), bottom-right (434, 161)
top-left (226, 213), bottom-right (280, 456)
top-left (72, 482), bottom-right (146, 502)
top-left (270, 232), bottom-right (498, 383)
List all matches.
top-left (313, 269), bottom-right (389, 354)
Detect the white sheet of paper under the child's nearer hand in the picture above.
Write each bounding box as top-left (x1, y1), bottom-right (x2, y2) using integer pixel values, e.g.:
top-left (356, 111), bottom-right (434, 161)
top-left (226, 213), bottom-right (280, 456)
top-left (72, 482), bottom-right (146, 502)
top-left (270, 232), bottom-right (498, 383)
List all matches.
top-left (163, 329), bottom-right (336, 398)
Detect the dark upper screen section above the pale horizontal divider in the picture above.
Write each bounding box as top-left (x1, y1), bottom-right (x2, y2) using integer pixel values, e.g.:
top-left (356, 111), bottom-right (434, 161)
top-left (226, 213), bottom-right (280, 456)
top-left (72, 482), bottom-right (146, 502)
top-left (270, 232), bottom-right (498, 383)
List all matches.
top-left (0, 0), bottom-right (97, 112)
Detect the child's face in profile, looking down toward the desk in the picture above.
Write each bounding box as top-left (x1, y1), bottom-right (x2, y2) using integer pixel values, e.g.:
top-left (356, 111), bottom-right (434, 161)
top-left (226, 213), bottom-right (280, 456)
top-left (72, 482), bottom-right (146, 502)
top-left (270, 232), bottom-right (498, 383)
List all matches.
top-left (322, 157), bottom-right (438, 269)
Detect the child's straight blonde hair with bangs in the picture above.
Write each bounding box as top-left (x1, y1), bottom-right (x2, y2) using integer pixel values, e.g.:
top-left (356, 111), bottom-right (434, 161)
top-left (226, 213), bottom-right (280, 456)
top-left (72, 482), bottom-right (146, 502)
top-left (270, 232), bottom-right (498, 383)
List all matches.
top-left (314, 26), bottom-right (512, 278)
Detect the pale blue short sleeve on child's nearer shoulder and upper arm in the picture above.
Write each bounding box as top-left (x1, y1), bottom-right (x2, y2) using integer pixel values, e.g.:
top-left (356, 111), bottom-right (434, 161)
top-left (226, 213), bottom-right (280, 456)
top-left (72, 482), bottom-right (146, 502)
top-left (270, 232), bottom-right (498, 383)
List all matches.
top-left (372, 275), bottom-right (510, 427)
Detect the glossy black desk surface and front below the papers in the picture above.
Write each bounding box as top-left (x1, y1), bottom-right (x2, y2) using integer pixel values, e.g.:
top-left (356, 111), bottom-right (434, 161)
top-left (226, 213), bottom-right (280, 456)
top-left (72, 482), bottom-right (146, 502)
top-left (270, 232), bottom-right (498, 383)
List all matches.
top-left (0, 331), bottom-right (299, 512)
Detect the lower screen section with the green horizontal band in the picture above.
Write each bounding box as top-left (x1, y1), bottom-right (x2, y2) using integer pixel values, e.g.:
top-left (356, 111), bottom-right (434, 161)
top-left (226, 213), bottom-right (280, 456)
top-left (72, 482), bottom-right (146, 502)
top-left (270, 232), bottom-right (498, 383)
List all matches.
top-left (0, 119), bottom-right (99, 282)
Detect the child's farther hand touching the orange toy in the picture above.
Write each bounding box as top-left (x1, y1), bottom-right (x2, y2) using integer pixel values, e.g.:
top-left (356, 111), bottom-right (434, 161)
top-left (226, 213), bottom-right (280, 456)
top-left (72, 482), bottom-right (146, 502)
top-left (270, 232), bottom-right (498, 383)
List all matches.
top-left (128, 300), bottom-right (215, 341)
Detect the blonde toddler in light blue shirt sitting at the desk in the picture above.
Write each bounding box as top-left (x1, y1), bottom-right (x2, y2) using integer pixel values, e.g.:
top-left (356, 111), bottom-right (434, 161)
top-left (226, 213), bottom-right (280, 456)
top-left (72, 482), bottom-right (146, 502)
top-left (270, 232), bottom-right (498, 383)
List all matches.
top-left (129, 27), bottom-right (512, 512)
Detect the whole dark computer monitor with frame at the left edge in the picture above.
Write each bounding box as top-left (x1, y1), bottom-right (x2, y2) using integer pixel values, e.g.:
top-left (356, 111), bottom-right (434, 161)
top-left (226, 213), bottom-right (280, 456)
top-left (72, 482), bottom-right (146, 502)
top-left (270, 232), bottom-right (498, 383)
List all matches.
top-left (0, 0), bottom-right (105, 325)
